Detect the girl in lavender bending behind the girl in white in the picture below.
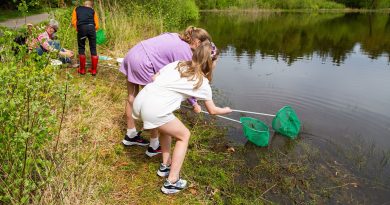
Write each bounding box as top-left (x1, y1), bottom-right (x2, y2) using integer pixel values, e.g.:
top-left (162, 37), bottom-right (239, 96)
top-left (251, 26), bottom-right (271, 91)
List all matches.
top-left (120, 26), bottom-right (211, 157)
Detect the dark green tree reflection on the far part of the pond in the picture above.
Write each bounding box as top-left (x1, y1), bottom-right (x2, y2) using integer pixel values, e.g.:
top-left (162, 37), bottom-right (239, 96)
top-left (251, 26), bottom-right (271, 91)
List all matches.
top-left (201, 13), bottom-right (390, 65)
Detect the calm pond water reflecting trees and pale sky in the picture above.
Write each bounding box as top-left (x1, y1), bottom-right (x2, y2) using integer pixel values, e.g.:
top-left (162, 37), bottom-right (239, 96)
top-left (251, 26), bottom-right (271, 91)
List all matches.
top-left (198, 12), bottom-right (390, 203)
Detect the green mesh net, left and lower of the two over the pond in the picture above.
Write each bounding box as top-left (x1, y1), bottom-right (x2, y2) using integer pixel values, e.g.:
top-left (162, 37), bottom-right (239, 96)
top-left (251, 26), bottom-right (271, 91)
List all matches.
top-left (240, 117), bottom-right (269, 147)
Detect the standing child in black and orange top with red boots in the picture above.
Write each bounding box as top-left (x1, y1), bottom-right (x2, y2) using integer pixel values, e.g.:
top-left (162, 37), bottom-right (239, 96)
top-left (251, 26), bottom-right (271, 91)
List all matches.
top-left (72, 1), bottom-right (99, 75)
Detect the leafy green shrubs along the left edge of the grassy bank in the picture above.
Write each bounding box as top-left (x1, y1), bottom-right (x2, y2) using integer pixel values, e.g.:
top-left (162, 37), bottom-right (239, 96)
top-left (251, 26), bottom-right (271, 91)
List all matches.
top-left (0, 27), bottom-right (67, 204)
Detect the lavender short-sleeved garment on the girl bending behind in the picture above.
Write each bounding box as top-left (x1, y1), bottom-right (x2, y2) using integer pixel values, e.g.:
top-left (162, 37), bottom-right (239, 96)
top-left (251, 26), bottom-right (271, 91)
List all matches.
top-left (120, 33), bottom-right (192, 85)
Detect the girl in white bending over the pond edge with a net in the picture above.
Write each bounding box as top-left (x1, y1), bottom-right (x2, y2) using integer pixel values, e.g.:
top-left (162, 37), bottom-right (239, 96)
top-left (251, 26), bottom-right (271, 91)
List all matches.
top-left (133, 41), bottom-right (231, 194)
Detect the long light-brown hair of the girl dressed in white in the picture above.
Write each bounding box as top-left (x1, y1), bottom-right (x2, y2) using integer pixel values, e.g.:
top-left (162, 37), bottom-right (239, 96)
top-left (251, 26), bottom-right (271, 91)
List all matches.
top-left (177, 41), bottom-right (219, 89)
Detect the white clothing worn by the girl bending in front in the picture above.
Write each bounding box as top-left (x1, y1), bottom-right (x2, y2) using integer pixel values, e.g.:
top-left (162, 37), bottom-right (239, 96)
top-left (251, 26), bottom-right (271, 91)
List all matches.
top-left (133, 61), bottom-right (212, 129)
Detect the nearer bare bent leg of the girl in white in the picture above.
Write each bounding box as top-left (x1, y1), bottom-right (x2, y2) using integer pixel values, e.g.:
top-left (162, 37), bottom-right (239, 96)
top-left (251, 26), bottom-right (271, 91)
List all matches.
top-left (158, 118), bottom-right (191, 182)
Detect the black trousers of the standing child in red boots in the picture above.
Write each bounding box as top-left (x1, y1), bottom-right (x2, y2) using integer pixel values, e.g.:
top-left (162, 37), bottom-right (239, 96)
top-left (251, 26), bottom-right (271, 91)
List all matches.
top-left (77, 24), bottom-right (97, 56)
